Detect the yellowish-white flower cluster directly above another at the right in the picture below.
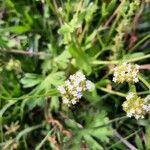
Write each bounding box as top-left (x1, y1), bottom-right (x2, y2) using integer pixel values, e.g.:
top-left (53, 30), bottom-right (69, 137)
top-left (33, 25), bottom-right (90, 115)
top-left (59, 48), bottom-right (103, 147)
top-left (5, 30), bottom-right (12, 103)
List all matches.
top-left (113, 63), bottom-right (140, 83)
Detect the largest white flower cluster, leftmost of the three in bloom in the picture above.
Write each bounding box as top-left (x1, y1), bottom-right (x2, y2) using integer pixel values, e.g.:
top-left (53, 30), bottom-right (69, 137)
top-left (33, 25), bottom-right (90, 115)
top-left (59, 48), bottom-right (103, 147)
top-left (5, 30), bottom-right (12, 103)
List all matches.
top-left (58, 71), bottom-right (92, 106)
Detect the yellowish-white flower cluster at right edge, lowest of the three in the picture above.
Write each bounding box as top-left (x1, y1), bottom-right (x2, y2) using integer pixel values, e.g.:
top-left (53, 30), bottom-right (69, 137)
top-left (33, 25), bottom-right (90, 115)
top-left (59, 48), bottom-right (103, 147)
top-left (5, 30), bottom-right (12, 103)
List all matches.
top-left (122, 92), bottom-right (150, 119)
